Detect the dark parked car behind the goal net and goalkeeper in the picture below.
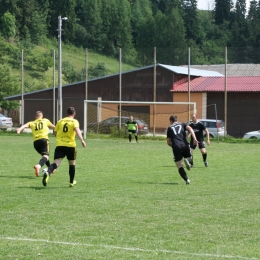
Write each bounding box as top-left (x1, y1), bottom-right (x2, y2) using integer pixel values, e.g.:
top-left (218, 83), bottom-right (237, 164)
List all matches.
top-left (87, 116), bottom-right (149, 134)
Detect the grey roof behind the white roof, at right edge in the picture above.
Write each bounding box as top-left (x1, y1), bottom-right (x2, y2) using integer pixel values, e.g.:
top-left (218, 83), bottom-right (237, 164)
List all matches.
top-left (184, 64), bottom-right (260, 77)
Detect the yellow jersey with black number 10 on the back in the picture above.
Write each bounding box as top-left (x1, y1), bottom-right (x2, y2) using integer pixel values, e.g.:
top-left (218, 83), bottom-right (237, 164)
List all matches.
top-left (29, 118), bottom-right (51, 141)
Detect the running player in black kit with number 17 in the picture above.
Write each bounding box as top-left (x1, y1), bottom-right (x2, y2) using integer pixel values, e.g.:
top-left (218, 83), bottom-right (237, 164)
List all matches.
top-left (167, 115), bottom-right (198, 184)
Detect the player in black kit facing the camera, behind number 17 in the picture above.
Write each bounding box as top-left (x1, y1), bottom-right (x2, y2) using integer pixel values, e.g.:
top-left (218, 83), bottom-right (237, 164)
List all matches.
top-left (190, 114), bottom-right (210, 167)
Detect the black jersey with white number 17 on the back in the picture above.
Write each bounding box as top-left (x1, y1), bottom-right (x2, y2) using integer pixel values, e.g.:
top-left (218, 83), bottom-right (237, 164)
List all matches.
top-left (167, 123), bottom-right (188, 146)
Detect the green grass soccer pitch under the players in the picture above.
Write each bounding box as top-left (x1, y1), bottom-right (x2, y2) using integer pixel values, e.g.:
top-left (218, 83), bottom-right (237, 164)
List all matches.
top-left (0, 135), bottom-right (260, 260)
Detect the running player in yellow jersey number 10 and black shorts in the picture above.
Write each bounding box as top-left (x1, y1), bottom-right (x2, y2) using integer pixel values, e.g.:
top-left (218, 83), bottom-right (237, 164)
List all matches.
top-left (16, 111), bottom-right (55, 177)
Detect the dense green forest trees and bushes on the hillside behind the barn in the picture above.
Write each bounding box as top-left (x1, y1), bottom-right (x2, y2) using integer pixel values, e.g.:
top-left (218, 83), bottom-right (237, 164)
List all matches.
top-left (0, 0), bottom-right (260, 108)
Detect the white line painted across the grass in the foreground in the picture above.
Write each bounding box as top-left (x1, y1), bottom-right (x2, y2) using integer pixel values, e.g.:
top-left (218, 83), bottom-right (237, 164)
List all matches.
top-left (0, 236), bottom-right (260, 260)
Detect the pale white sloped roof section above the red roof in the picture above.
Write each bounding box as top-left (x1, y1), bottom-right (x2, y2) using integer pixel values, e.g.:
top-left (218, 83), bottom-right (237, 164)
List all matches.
top-left (158, 64), bottom-right (224, 77)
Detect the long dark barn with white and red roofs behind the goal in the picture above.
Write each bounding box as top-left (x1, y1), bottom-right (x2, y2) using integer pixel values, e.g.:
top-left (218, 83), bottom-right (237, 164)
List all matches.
top-left (6, 64), bottom-right (260, 137)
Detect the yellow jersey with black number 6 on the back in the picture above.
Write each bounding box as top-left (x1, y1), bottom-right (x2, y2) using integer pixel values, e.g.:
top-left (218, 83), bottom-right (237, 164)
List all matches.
top-left (54, 117), bottom-right (79, 147)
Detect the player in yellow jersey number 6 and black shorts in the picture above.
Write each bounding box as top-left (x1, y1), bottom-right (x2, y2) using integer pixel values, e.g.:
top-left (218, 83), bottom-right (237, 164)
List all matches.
top-left (42, 107), bottom-right (86, 187)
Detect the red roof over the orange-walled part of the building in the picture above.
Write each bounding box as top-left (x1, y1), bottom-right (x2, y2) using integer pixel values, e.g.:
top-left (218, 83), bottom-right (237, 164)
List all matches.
top-left (171, 76), bottom-right (260, 92)
